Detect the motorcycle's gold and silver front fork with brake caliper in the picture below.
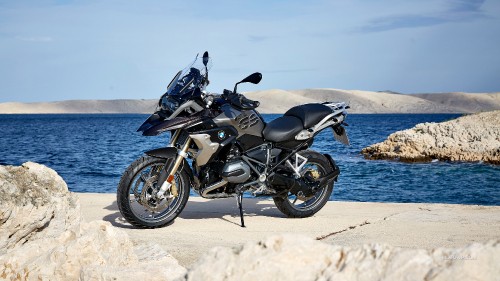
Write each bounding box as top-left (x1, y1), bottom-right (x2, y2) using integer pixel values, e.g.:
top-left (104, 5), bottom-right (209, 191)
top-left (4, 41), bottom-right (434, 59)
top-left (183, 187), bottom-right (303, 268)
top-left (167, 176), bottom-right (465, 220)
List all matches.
top-left (156, 130), bottom-right (191, 198)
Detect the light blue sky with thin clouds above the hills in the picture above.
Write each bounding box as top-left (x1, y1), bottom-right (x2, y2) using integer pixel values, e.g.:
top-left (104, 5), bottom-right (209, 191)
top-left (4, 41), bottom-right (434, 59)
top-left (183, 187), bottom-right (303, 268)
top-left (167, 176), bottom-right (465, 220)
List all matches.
top-left (0, 0), bottom-right (500, 102)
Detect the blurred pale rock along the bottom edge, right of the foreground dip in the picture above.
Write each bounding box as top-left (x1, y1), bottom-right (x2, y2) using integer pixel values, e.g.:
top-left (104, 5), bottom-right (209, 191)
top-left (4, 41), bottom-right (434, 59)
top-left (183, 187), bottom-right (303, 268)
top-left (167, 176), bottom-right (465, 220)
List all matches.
top-left (187, 235), bottom-right (500, 281)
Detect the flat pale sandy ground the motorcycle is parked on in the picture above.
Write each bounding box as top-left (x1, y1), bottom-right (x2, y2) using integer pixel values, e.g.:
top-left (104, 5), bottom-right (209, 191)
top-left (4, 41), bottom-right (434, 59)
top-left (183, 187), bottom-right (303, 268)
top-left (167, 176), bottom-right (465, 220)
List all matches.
top-left (78, 193), bottom-right (500, 266)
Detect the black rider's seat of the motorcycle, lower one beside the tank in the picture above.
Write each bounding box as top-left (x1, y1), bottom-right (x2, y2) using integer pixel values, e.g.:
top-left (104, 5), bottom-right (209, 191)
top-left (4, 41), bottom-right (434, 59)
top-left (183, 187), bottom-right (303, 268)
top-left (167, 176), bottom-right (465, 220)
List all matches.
top-left (262, 116), bottom-right (304, 142)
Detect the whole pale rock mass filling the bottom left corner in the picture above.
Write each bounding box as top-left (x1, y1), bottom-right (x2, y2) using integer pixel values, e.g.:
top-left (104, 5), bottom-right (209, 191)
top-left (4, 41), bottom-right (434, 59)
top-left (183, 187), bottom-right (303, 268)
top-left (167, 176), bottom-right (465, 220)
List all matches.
top-left (0, 162), bottom-right (186, 280)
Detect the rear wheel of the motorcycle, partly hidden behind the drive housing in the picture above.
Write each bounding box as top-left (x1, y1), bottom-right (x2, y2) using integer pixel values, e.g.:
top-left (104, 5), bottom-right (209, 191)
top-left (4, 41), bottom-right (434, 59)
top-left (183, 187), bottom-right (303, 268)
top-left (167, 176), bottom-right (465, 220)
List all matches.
top-left (273, 150), bottom-right (333, 218)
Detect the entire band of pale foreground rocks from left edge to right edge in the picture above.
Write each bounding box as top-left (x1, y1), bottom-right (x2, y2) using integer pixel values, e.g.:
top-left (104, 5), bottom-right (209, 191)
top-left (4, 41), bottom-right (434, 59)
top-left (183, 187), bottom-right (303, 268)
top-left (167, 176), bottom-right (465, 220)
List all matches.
top-left (0, 162), bottom-right (500, 280)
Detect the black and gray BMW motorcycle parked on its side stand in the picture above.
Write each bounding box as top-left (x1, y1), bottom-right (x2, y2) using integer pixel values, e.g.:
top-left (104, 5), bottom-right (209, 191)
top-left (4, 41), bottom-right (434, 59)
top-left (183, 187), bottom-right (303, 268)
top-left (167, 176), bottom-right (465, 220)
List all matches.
top-left (117, 52), bottom-right (349, 228)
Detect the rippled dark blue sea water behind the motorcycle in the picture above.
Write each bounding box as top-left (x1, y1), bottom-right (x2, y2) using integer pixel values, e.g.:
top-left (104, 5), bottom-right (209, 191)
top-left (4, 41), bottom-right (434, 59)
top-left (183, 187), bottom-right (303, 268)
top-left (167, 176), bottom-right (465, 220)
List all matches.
top-left (0, 114), bottom-right (500, 205)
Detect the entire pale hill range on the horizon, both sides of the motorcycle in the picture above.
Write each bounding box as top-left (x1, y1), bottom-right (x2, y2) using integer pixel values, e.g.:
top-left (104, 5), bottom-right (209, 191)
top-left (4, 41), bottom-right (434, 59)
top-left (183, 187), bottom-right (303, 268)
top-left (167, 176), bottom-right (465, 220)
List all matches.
top-left (0, 89), bottom-right (500, 114)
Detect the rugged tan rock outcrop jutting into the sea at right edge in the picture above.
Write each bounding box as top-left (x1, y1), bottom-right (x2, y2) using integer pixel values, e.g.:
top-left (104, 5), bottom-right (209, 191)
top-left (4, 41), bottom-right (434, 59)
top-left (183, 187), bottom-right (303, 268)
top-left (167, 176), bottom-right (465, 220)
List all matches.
top-left (361, 110), bottom-right (500, 165)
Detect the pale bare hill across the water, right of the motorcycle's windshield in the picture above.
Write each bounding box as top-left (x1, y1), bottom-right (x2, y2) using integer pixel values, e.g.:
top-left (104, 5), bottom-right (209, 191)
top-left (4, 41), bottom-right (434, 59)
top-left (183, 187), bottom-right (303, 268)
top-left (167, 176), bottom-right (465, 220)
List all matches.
top-left (245, 89), bottom-right (500, 113)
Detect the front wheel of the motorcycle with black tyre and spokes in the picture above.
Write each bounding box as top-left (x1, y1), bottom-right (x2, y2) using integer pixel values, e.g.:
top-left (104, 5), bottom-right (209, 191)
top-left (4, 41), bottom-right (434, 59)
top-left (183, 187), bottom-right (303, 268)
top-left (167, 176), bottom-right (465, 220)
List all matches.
top-left (117, 156), bottom-right (190, 228)
